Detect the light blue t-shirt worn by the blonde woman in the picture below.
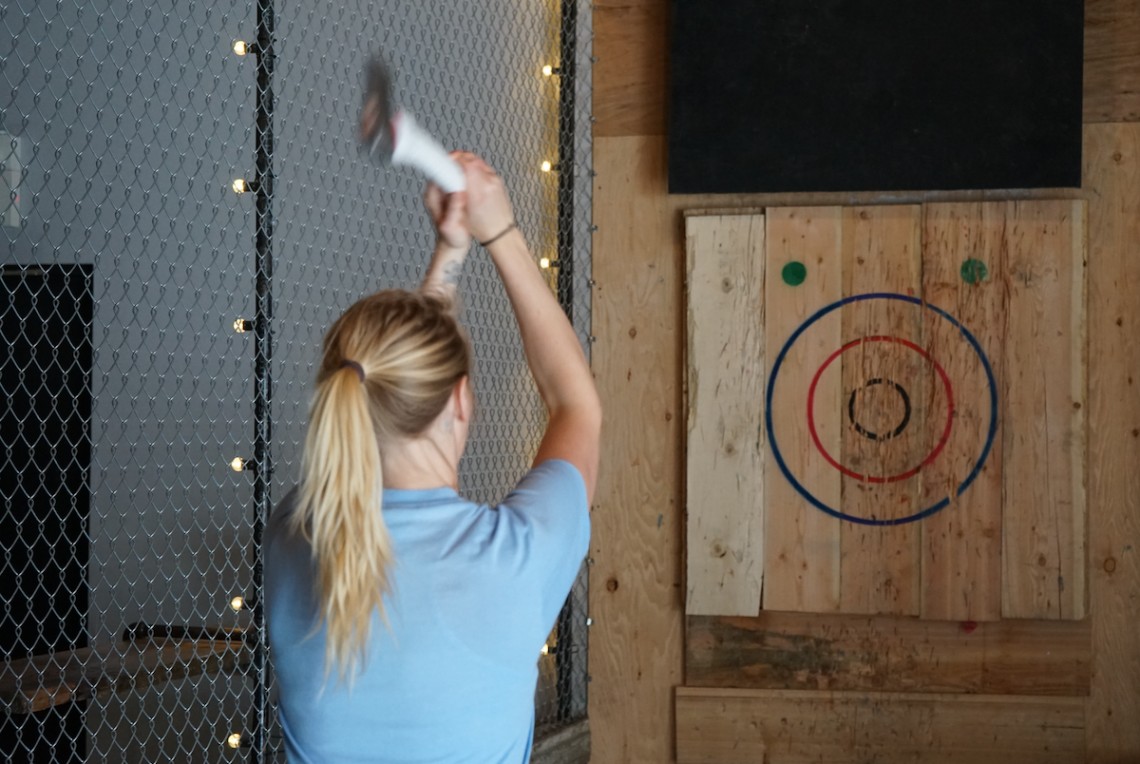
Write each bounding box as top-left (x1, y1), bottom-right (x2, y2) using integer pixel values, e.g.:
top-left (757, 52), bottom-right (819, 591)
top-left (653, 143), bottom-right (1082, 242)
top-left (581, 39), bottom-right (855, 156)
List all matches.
top-left (264, 460), bottom-right (589, 764)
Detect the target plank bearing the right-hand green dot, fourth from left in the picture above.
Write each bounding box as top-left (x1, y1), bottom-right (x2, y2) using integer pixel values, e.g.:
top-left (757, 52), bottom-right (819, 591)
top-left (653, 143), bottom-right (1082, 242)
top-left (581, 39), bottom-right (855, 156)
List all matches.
top-left (920, 202), bottom-right (1009, 621)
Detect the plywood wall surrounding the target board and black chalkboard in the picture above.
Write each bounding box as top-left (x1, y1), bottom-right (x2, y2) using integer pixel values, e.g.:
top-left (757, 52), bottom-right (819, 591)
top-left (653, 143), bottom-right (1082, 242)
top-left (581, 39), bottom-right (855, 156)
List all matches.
top-left (589, 0), bottom-right (1140, 764)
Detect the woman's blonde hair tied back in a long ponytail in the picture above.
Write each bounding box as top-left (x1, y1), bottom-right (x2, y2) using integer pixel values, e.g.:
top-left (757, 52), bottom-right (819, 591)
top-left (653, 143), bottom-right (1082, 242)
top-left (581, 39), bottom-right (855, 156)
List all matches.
top-left (292, 290), bottom-right (471, 680)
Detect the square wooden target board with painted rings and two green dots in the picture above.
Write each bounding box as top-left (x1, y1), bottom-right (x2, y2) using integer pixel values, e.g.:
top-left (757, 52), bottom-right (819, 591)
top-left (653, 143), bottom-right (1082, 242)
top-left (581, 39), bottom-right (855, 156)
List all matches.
top-left (686, 201), bottom-right (1085, 620)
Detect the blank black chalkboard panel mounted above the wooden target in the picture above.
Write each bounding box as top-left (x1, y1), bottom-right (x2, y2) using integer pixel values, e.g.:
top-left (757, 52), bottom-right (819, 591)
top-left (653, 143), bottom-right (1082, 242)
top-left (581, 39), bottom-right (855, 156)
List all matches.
top-left (669, 0), bottom-right (1083, 193)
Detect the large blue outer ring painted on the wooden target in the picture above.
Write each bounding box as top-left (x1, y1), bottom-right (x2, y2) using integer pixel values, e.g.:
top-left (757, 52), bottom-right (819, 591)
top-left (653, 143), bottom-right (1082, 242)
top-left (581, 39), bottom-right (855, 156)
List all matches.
top-left (764, 292), bottom-right (998, 526)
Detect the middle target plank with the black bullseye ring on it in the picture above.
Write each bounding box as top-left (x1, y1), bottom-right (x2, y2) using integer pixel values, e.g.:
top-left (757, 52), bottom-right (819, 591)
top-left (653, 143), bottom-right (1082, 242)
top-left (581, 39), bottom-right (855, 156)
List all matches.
top-left (830, 205), bottom-right (934, 615)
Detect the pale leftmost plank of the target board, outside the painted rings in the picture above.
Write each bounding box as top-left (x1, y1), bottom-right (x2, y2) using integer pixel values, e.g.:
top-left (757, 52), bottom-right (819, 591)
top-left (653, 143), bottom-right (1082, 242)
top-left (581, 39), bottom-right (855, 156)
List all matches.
top-left (685, 216), bottom-right (764, 616)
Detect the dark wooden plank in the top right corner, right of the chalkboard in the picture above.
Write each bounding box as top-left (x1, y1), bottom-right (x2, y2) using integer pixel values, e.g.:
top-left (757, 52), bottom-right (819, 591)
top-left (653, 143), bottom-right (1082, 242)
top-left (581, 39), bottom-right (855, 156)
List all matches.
top-left (1084, 0), bottom-right (1140, 123)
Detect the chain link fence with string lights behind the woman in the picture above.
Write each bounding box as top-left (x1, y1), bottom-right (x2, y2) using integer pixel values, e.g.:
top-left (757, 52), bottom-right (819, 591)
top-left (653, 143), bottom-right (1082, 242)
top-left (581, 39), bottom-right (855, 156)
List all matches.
top-left (0, 0), bottom-right (592, 763)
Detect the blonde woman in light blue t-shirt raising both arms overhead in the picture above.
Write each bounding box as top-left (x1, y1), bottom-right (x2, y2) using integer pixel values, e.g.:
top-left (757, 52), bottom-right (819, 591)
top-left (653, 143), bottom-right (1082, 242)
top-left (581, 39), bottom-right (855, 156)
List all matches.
top-left (266, 154), bottom-right (601, 764)
